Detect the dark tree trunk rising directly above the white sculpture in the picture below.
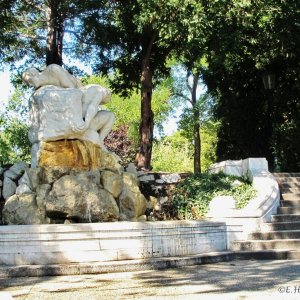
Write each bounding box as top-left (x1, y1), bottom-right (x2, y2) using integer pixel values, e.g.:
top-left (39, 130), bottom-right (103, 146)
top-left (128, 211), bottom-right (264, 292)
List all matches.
top-left (46, 0), bottom-right (64, 66)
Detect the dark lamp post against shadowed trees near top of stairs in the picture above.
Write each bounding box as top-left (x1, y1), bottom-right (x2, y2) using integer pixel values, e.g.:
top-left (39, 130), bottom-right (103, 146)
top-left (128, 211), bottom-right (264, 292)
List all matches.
top-left (262, 72), bottom-right (275, 171)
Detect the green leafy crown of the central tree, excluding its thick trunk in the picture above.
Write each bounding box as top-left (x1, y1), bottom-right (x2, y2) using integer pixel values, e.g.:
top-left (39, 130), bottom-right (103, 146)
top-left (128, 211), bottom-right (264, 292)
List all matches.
top-left (81, 0), bottom-right (201, 95)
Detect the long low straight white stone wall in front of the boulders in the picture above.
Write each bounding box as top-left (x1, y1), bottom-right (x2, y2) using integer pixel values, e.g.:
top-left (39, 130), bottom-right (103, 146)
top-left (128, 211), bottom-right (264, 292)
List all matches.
top-left (0, 221), bottom-right (227, 265)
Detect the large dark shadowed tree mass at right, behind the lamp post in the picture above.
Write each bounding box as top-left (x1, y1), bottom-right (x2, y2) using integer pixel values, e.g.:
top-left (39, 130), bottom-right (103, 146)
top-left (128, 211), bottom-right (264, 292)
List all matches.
top-left (200, 0), bottom-right (300, 169)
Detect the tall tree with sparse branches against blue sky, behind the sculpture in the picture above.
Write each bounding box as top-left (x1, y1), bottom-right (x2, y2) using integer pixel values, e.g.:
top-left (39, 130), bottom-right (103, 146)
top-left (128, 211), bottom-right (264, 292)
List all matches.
top-left (0, 0), bottom-right (87, 67)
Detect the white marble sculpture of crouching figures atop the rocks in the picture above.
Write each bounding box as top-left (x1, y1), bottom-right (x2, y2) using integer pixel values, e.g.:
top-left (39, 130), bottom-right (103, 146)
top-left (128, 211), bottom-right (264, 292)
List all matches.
top-left (22, 64), bottom-right (115, 167)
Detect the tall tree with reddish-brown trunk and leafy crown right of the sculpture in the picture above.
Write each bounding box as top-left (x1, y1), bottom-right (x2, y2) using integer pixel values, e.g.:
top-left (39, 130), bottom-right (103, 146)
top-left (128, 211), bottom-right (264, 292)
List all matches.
top-left (79, 0), bottom-right (204, 169)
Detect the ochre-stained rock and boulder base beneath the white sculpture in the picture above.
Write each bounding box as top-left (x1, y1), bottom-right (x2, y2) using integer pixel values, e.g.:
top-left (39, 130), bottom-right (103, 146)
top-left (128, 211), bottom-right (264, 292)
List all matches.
top-left (2, 140), bottom-right (147, 225)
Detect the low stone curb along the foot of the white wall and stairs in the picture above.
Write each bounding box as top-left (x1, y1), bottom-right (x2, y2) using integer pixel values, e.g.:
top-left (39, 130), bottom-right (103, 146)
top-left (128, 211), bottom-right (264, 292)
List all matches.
top-left (0, 250), bottom-right (300, 279)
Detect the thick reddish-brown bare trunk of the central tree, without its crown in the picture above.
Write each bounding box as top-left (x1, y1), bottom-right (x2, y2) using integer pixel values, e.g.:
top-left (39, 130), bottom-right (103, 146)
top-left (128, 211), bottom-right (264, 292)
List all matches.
top-left (135, 57), bottom-right (154, 170)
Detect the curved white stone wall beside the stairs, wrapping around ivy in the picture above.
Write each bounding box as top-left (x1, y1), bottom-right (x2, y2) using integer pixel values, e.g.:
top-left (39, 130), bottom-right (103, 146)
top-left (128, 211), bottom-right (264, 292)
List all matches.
top-left (208, 158), bottom-right (280, 248)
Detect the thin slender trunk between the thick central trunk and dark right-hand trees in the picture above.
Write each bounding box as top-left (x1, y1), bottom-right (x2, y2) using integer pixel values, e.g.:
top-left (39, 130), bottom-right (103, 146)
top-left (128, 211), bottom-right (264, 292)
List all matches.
top-left (191, 74), bottom-right (201, 173)
